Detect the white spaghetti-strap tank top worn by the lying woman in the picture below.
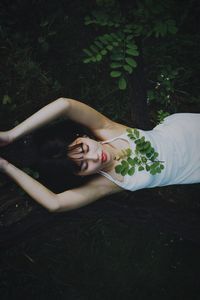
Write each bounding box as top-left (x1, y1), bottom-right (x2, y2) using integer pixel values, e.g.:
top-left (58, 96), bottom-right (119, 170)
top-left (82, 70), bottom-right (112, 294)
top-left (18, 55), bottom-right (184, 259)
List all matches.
top-left (98, 113), bottom-right (200, 191)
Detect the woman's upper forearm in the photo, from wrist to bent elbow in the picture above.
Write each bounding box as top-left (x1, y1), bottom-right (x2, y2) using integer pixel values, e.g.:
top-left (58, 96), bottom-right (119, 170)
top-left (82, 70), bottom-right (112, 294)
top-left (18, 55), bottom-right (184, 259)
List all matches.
top-left (7, 98), bottom-right (68, 142)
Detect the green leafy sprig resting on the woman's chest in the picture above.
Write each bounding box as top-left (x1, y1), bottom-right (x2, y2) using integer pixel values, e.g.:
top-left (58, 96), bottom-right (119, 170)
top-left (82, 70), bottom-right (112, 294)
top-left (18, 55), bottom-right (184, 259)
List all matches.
top-left (115, 128), bottom-right (164, 176)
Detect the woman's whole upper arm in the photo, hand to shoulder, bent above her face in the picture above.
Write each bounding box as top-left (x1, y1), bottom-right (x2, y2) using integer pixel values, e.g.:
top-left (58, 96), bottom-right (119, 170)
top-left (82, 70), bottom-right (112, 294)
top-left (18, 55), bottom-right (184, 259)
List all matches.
top-left (3, 98), bottom-right (120, 146)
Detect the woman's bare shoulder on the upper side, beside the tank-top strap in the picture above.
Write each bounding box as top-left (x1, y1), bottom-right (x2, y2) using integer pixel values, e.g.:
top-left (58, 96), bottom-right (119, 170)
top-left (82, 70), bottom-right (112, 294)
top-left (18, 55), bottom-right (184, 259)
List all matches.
top-left (93, 120), bottom-right (129, 141)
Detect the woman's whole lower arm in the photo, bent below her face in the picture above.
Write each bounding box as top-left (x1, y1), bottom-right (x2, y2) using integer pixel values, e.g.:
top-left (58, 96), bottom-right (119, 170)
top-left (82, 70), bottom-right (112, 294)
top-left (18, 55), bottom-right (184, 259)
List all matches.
top-left (0, 162), bottom-right (122, 212)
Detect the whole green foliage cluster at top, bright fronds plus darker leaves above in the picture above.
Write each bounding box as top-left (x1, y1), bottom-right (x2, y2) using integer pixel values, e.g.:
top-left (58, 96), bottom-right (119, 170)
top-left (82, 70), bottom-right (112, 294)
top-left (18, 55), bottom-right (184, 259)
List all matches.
top-left (83, 0), bottom-right (177, 90)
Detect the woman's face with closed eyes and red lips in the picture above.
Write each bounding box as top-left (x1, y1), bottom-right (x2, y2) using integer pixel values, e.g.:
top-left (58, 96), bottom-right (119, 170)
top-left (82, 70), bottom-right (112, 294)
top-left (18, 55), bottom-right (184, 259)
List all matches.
top-left (70, 137), bottom-right (113, 176)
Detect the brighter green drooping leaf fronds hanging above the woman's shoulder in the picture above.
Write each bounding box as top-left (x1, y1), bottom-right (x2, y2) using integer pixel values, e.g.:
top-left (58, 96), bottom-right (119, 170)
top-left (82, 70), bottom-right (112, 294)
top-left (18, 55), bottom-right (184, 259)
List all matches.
top-left (83, 22), bottom-right (139, 90)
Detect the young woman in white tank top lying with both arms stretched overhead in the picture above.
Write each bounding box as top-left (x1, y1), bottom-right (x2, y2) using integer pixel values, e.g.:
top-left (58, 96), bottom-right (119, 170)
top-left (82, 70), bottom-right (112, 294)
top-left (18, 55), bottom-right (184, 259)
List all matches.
top-left (0, 98), bottom-right (200, 212)
